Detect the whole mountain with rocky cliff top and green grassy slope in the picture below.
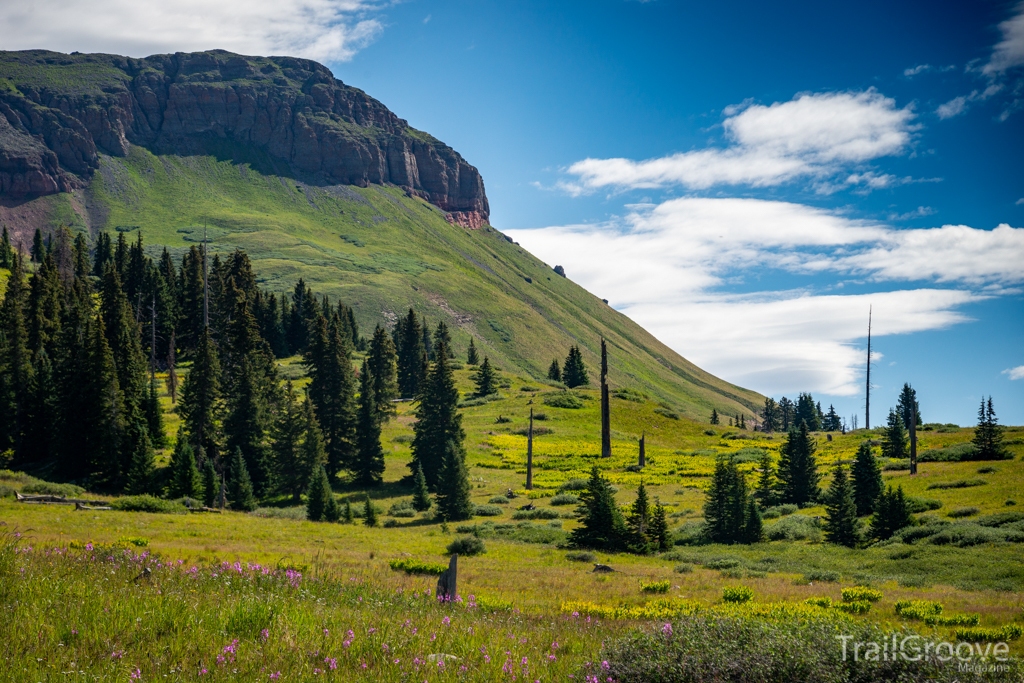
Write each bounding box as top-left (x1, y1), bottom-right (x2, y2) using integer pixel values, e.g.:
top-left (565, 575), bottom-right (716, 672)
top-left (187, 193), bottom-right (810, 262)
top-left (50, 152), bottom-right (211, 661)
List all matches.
top-left (0, 50), bottom-right (763, 420)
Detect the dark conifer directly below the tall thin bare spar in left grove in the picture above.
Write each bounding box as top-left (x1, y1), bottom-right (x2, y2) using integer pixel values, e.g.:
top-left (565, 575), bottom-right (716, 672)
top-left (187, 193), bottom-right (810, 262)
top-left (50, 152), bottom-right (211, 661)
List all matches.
top-left (178, 329), bottom-right (220, 458)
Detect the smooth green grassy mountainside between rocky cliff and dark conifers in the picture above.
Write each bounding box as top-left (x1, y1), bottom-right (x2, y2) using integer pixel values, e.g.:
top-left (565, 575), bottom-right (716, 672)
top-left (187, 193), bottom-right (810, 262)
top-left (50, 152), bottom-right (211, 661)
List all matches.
top-left (61, 147), bottom-right (762, 418)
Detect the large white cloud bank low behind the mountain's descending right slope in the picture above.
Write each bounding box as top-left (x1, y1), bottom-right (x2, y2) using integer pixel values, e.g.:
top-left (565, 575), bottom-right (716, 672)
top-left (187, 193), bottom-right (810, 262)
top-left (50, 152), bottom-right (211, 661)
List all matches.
top-left (509, 198), bottom-right (1024, 394)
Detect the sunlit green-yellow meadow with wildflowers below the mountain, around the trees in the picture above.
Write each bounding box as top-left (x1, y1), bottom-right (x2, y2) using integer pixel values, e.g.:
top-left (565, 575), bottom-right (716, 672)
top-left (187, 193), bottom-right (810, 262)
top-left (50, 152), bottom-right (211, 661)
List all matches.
top-left (0, 358), bottom-right (1024, 681)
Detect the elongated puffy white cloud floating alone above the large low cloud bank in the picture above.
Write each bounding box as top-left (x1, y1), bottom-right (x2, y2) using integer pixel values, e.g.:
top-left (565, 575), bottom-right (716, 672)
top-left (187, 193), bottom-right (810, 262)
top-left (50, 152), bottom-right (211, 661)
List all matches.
top-left (562, 89), bottom-right (914, 194)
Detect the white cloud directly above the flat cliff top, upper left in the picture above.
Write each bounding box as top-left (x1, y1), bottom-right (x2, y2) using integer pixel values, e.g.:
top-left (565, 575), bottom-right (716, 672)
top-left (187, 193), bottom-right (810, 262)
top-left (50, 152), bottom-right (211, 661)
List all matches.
top-left (0, 0), bottom-right (382, 61)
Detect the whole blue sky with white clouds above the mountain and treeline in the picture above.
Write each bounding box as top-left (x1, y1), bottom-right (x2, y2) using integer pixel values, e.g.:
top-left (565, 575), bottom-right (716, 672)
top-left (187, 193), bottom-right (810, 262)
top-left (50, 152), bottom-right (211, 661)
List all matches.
top-left (0, 0), bottom-right (1024, 426)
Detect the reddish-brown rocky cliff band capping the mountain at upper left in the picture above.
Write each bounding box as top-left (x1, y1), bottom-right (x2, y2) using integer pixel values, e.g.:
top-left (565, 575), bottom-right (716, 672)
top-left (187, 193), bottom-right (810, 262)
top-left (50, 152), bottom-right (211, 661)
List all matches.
top-left (0, 50), bottom-right (489, 228)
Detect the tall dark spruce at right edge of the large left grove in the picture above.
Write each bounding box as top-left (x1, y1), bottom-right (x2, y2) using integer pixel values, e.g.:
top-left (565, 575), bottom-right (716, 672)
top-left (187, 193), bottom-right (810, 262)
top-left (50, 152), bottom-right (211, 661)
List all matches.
top-left (409, 333), bottom-right (466, 489)
